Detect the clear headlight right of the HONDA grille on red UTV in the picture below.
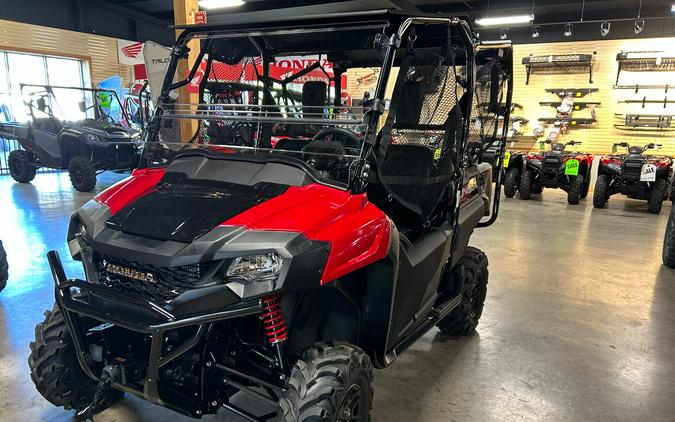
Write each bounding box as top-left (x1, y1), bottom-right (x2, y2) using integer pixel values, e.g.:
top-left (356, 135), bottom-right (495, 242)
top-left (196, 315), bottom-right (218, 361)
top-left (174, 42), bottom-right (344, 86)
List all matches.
top-left (225, 252), bottom-right (284, 298)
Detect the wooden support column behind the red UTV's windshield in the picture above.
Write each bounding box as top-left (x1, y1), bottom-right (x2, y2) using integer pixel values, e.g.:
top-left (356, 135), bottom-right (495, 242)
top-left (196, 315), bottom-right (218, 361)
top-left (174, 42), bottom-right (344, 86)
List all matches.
top-left (173, 0), bottom-right (199, 143)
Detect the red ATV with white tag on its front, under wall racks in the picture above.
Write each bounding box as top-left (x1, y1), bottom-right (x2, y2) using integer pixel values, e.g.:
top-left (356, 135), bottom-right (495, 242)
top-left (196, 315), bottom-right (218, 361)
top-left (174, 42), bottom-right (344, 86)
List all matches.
top-left (593, 142), bottom-right (673, 214)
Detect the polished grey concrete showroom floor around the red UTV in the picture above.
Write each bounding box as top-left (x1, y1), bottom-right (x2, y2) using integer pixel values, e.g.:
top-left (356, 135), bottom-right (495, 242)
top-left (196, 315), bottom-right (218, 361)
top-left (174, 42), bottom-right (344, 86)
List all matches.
top-left (0, 174), bottom-right (675, 422)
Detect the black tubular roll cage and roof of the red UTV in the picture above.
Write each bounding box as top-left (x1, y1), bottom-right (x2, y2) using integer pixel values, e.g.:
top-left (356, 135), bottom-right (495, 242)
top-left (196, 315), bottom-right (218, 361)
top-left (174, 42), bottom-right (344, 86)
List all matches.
top-left (142, 11), bottom-right (512, 234)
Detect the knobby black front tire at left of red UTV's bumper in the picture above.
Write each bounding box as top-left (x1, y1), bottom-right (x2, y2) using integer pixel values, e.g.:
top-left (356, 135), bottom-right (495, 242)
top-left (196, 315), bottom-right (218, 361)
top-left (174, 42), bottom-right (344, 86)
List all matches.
top-left (28, 306), bottom-right (123, 412)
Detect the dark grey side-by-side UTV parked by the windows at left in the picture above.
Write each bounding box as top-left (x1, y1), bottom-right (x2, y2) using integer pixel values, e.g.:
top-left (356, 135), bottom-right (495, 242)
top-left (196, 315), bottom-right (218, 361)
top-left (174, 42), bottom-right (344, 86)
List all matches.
top-left (0, 84), bottom-right (141, 192)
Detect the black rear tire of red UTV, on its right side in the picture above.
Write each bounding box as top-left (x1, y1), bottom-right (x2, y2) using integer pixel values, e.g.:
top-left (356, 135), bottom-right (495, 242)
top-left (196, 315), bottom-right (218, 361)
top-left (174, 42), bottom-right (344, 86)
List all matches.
top-left (436, 246), bottom-right (489, 337)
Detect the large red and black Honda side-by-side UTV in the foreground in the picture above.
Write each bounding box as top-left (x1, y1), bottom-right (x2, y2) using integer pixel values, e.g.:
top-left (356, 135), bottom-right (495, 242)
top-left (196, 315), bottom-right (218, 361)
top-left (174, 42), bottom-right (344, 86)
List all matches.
top-left (28, 12), bottom-right (513, 421)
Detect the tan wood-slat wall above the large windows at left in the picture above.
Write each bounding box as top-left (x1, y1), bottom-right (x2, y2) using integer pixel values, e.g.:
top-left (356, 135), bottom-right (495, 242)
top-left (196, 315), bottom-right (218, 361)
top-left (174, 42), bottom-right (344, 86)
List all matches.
top-left (0, 20), bottom-right (132, 85)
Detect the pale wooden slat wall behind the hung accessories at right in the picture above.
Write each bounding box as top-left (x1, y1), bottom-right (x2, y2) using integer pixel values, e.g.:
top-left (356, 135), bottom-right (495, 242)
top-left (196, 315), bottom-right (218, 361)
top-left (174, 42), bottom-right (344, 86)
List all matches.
top-left (513, 38), bottom-right (675, 155)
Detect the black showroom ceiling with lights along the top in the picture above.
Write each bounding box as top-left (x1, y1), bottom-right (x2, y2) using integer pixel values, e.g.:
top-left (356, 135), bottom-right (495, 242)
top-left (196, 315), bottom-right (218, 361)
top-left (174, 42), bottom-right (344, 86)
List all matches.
top-left (0, 0), bottom-right (675, 43)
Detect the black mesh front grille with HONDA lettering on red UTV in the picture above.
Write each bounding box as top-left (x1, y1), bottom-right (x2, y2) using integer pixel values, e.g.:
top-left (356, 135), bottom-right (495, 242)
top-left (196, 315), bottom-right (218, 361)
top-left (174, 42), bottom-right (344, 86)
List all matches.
top-left (94, 253), bottom-right (207, 303)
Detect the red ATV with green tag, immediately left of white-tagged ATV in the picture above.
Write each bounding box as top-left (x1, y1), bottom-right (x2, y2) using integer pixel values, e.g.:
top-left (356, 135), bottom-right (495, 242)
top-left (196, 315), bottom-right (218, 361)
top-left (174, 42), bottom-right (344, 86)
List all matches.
top-left (520, 140), bottom-right (593, 205)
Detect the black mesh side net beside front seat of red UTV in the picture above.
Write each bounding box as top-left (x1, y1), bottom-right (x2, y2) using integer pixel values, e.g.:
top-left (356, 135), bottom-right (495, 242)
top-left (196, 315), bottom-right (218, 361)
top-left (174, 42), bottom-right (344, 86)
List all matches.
top-left (379, 57), bottom-right (463, 219)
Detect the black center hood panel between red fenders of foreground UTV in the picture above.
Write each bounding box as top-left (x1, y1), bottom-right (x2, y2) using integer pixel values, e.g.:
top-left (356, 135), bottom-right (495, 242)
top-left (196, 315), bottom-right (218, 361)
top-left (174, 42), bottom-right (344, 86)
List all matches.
top-left (107, 181), bottom-right (288, 242)
